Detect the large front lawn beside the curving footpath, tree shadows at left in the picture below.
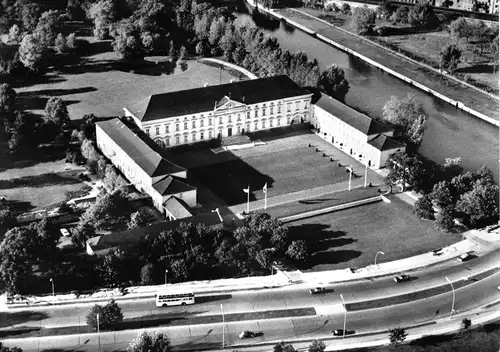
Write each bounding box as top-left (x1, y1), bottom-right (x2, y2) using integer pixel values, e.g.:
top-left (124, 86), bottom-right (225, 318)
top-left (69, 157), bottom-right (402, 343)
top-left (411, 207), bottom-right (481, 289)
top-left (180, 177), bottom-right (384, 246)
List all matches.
top-left (287, 196), bottom-right (459, 271)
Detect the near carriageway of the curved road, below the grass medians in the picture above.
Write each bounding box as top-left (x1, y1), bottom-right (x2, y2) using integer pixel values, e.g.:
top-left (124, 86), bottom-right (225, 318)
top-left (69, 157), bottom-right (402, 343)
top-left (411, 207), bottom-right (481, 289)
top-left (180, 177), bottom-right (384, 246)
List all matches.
top-left (3, 268), bottom-right (500, 351)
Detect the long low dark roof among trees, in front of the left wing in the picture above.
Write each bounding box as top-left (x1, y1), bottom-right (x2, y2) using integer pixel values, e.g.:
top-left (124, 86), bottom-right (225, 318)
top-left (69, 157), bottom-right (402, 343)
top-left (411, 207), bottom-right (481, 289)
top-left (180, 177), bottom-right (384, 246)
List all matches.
top-left (87, 212), bottom-right (223, 255)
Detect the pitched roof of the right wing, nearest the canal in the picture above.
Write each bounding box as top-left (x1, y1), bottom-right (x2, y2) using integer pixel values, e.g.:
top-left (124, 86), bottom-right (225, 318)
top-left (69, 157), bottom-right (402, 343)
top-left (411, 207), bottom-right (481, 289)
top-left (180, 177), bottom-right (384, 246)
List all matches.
top-left (316, 94), bottom-right (392, 136)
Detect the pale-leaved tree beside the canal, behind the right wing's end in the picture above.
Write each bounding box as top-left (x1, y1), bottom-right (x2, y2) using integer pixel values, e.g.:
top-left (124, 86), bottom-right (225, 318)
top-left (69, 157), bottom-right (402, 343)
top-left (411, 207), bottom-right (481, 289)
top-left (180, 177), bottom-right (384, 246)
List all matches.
top-left (382, 94), bottom-right (427, 149)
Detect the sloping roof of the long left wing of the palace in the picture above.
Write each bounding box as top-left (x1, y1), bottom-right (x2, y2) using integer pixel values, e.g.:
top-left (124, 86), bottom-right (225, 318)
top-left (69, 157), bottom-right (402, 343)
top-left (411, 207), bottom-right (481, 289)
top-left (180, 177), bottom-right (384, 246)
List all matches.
top-left (97, 119), bottom-right (186, 177)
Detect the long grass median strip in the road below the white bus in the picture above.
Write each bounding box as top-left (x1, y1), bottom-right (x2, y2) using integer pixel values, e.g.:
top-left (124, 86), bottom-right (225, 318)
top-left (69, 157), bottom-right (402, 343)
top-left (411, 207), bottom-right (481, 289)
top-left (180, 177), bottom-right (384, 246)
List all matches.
top-left (0, 308), bottom-right (316, 338)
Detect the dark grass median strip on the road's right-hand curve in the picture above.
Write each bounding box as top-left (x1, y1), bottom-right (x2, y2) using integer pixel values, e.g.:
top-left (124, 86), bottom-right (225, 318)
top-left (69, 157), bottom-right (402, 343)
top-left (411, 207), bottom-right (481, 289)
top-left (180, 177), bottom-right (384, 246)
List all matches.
top-left (346, 268), bottom-right (500, 311)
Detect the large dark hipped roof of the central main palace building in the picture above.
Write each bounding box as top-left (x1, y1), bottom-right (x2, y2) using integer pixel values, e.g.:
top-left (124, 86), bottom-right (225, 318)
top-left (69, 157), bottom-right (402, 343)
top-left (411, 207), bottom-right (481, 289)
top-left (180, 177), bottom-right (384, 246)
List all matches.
top-left (127, 75), bottom-right (311, 121)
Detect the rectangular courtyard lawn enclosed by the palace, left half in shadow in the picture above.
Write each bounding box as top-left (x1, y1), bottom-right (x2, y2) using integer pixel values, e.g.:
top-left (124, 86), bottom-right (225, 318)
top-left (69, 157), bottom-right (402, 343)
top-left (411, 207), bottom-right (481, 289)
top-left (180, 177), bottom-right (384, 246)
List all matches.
top-left (192, 145), bottom-right (348, 205)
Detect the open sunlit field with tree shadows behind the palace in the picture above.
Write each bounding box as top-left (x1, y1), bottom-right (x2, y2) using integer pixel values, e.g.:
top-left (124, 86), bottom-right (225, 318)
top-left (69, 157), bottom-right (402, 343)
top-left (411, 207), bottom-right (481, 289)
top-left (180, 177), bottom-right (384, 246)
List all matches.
top-left (16, 47), bottom-right (241, 120)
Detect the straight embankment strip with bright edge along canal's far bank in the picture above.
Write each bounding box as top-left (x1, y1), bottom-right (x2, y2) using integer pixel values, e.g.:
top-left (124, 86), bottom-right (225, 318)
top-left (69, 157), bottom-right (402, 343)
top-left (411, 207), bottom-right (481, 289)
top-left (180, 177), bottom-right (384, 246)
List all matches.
top-left (252, 0), bottom-right (499, 126)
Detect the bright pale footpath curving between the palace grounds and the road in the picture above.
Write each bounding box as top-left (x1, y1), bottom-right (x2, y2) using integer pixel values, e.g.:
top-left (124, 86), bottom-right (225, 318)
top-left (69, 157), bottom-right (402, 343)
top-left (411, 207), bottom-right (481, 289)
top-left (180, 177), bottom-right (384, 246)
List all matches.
top-left (0, 226), bottom-right (500, 311)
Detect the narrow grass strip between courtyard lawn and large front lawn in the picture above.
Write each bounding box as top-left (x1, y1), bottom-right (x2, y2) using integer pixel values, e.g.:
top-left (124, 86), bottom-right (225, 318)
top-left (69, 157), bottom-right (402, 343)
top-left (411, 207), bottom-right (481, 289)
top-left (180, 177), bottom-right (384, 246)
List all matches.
top-left (267, 187), bottom-right (380, 218)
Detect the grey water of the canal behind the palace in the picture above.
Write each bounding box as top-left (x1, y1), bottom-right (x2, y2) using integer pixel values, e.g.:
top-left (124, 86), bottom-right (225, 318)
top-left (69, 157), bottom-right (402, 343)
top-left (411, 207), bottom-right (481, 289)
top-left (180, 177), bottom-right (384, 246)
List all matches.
top-left (235, 8), bottom-right (499, 182)
